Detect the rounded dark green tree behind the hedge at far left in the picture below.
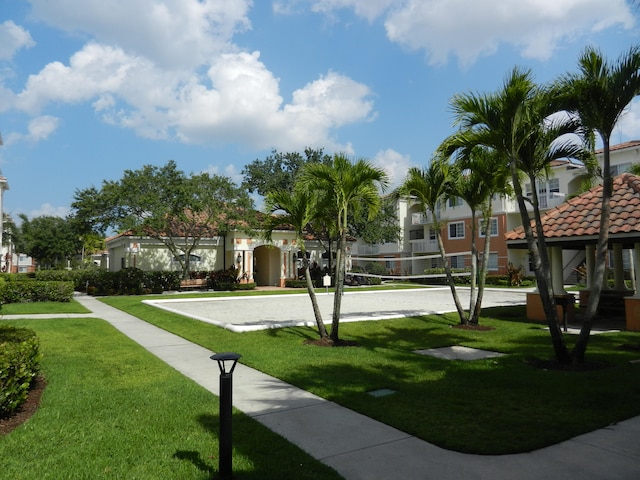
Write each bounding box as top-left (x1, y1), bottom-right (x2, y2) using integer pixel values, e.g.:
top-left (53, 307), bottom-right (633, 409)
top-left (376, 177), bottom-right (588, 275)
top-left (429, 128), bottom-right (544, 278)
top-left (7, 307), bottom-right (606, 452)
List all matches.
top-left (16, 214), bottom-right (82, 269)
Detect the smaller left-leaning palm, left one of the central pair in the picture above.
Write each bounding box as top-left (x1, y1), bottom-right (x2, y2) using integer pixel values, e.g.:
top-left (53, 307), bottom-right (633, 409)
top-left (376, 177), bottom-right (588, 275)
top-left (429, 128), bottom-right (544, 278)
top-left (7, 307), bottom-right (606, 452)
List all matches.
top-left (264, 190), bottom-right (329, 340)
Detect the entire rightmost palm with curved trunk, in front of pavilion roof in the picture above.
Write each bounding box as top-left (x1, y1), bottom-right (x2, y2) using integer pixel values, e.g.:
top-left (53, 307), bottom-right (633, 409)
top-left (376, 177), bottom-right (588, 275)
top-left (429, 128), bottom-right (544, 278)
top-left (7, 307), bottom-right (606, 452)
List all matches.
top-left (557, 46), bottom-right (640, 361)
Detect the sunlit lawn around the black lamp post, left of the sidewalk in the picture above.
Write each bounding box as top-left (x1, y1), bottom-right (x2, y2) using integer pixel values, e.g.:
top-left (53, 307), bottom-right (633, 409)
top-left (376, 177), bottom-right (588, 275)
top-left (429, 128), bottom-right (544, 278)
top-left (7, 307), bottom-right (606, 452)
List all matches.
top-left (0, 316), bottom-right (341, 480)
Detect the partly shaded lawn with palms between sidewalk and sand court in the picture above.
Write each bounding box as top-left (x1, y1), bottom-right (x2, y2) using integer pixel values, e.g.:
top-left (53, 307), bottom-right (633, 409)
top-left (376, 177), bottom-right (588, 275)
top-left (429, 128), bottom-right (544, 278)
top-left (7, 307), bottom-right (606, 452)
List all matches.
top-left (99, 297), bottom-right (640, 454)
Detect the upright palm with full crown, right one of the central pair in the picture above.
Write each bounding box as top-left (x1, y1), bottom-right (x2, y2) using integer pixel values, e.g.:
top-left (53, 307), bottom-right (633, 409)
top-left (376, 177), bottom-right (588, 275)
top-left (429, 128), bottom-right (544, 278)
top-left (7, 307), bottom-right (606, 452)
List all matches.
top-left (300, 154), bottom-right (388, 344)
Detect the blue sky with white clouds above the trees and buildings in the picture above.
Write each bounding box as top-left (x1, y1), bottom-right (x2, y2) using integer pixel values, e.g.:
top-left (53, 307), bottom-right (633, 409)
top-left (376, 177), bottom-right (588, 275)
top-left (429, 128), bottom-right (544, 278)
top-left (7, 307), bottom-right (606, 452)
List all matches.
top-left (0, 0), bottom-right (640, 218)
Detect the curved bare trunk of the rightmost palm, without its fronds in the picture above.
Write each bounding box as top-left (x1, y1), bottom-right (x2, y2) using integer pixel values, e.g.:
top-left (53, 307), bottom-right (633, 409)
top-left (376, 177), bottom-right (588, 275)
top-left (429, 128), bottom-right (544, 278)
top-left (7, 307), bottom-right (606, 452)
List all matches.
top-left (571, 135), bottom-right (613, 363)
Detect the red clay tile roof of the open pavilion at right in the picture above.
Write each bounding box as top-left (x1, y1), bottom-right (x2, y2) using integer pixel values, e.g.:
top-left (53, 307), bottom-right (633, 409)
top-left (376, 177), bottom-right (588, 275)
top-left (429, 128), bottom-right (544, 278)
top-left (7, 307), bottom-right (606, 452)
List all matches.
top-left (505, 173), bottom-right (640, 246)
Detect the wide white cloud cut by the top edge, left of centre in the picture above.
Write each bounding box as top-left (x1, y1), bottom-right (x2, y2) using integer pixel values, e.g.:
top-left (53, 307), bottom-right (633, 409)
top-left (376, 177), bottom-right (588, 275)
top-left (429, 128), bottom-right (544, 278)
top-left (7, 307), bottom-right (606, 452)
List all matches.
top-left (31, 0), bottom-right (251, 68)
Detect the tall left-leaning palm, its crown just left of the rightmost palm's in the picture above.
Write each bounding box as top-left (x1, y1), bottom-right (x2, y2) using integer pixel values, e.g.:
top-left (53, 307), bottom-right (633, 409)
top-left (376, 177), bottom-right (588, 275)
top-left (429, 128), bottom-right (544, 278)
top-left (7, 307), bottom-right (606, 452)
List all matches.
top-left (443, 68), bottom-right (575, 363)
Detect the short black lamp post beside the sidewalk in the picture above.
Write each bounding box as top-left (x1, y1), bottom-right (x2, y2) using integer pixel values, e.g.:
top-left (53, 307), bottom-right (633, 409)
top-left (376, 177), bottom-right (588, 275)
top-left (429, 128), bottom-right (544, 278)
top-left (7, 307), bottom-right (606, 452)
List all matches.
top-left (210, 352), bottom-right (242, 480)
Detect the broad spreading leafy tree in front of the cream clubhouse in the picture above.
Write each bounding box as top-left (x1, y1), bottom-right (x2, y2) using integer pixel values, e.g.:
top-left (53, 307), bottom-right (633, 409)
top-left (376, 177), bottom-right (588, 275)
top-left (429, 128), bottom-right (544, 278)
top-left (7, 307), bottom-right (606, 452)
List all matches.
top-left (72, 160), bottom-right (254, 278)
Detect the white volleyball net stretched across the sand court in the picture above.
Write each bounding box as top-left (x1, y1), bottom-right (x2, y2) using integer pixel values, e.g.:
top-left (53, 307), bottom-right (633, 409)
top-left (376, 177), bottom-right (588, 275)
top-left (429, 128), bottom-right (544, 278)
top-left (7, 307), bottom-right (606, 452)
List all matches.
top-left (347, 252), bottom-right (471, 281)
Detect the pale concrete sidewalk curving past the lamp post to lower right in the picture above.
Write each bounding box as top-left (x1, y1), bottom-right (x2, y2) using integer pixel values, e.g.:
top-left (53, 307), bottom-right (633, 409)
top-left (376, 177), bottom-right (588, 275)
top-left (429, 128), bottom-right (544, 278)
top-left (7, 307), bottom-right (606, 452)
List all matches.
top-left (35, 295), bottom-right (640, 480)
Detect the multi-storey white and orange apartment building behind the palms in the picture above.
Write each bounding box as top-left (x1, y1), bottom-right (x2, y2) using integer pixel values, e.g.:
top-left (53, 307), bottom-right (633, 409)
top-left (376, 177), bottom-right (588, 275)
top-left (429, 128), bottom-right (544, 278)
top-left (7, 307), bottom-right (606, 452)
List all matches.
top-left (352, 140), bottom-right (640, 282)
